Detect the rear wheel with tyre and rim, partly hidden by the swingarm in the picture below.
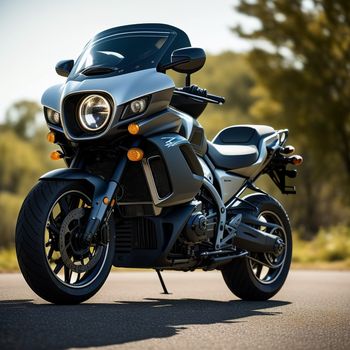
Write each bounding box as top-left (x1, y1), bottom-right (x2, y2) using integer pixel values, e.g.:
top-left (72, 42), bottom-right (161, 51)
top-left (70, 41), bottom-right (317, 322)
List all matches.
top-left (222, 194), bottom-right (292, 300)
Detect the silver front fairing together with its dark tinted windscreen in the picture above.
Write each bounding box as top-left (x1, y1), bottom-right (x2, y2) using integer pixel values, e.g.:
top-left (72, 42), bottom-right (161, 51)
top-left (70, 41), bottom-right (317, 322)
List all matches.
top-left (42, 24), bottom-right (190, 141)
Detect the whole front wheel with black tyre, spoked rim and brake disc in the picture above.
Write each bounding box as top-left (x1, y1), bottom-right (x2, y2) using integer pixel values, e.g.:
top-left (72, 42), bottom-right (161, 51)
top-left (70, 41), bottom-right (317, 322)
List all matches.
top-left (16, 181), bottom-right (115, 304)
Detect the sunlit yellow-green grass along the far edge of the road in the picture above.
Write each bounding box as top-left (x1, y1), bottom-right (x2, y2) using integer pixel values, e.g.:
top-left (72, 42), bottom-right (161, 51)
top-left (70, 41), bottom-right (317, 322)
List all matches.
top-left (0, 226), bottom-right (350, 273)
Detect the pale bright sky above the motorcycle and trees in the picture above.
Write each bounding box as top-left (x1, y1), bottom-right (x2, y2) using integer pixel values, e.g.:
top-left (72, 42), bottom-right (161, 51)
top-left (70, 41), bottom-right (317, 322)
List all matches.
top-left (0, 0), bottom-right (256, 121)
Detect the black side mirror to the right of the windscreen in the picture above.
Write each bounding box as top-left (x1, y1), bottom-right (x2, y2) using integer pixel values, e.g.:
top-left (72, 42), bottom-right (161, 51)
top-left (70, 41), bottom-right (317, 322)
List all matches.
top-left (171, 47), bottom-right (206, 74)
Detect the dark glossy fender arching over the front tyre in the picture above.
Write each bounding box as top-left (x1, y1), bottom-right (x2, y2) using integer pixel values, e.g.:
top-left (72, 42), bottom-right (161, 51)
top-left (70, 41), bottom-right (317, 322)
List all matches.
top-left (40, 168), bottom-right (107, 197)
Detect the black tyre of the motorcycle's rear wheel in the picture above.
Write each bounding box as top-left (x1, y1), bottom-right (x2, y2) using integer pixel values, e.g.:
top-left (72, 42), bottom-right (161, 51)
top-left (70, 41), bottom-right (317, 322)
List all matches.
top-left (221, 194), bottom-right (292, 300)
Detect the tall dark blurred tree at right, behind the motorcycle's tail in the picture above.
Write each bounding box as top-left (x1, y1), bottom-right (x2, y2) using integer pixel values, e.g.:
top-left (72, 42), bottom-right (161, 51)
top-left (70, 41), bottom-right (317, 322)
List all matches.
top-left (233, 0), bottom-right (350, 237)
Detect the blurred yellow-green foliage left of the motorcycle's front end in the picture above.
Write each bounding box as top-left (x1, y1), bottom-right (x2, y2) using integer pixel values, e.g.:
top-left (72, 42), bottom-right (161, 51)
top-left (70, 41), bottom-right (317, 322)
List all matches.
top-left (0, 101), bottom-right (62, 248)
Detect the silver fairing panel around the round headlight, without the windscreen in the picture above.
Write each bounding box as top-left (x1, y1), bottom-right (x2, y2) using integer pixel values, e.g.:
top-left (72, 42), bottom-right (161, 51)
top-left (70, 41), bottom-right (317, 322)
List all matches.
top-left (41, 68), bottom-right (175, 141)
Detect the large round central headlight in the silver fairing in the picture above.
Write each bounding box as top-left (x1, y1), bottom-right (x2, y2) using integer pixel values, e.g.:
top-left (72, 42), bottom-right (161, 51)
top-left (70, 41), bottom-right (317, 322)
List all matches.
top-left (79, 95), bottom-right (111, 131)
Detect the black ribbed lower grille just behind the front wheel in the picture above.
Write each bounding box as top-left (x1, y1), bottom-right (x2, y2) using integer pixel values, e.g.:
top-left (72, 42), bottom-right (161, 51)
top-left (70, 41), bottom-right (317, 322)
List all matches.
top-left (115, 218), bottom-right (157, 254)
